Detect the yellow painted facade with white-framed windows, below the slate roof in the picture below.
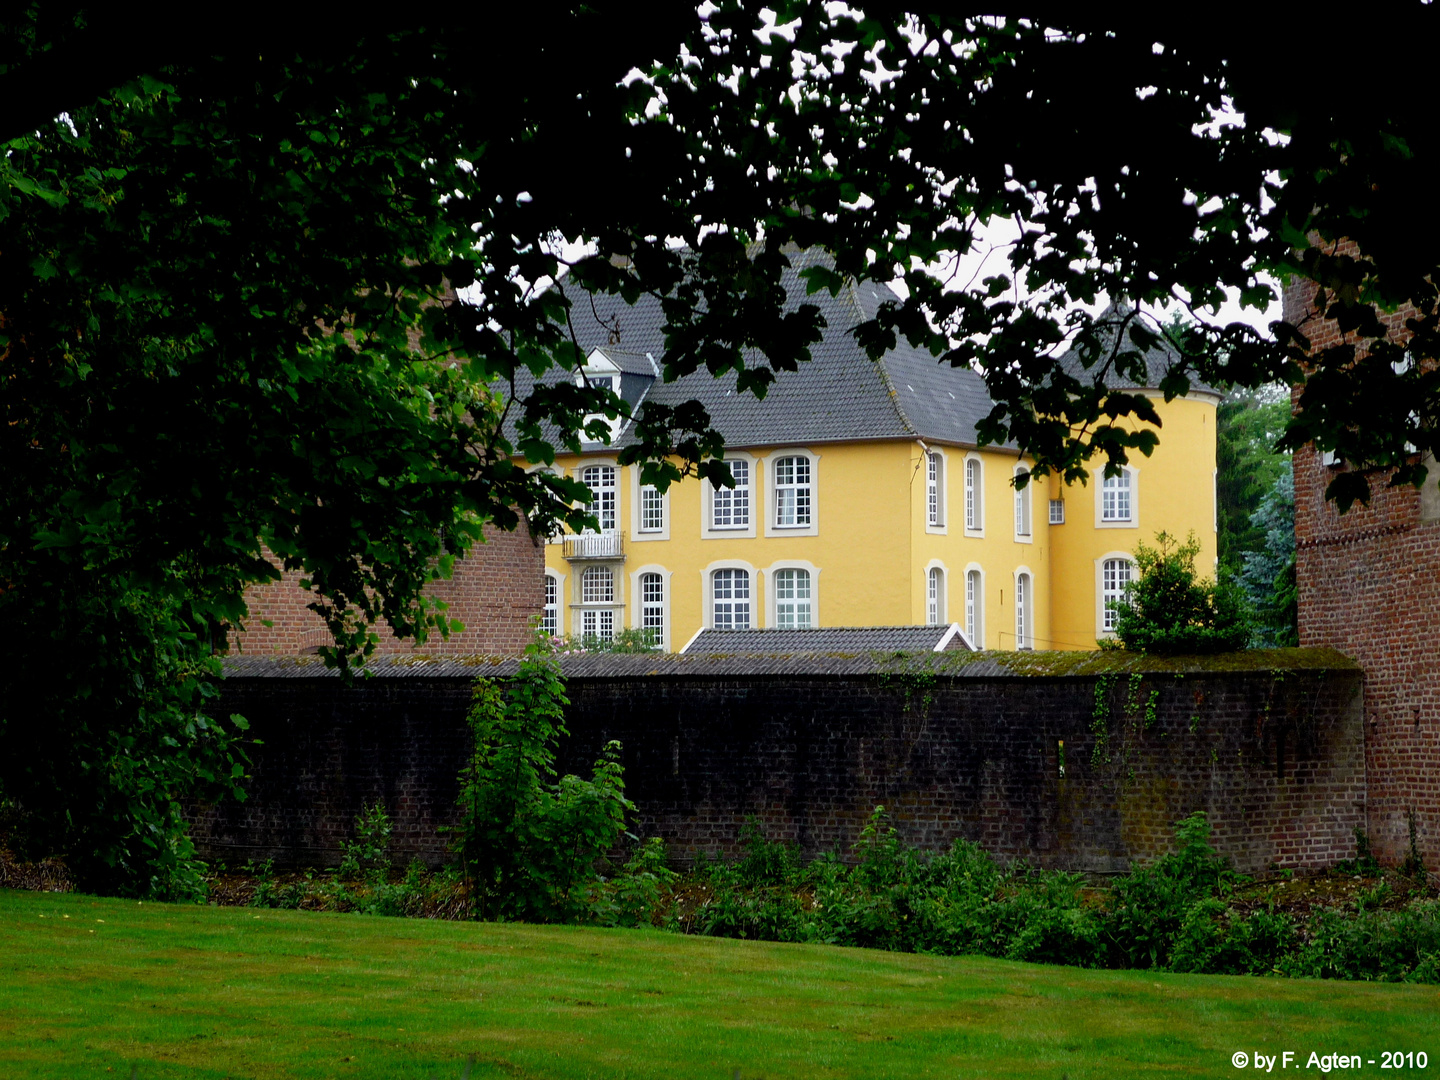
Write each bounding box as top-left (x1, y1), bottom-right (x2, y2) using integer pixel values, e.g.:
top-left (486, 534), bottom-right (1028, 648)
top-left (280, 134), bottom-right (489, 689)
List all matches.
top-left (529, 393), bottom-right (1218, 651)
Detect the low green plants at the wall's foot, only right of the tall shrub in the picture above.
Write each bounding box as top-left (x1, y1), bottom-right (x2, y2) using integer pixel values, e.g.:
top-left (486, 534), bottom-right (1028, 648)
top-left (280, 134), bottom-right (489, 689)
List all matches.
top-left (668, 806), bottom-right (1440, 982)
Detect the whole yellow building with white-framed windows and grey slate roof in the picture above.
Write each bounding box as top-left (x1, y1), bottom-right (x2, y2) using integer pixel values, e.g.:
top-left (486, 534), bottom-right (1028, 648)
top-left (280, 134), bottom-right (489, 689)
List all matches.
top-left (518, 259), bottom-right (1218, 651)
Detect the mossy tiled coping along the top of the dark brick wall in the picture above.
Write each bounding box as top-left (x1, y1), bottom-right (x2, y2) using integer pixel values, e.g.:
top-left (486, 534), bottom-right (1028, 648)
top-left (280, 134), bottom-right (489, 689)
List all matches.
top-left (223, 648), bottom-right (1361, 680)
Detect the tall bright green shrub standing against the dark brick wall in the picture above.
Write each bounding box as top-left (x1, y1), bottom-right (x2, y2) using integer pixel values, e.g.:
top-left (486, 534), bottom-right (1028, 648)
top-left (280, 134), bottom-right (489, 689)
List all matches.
top-left (454, 639), bottom-right (635, 920)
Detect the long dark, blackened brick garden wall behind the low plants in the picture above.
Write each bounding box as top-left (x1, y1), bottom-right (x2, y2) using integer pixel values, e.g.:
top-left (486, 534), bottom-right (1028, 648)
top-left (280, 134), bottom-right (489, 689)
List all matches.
top-left (196, 671), bottom-right (1365, 871)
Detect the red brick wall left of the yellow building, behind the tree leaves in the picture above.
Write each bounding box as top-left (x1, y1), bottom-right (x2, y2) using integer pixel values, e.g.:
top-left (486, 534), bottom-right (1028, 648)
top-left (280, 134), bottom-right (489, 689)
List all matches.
top-left (230, 523), bottom-right (544, 657)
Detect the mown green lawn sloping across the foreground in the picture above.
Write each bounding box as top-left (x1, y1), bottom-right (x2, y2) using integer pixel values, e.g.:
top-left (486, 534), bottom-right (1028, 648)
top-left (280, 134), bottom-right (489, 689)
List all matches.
top-left (0, 891), bottom-right (1440, 1080)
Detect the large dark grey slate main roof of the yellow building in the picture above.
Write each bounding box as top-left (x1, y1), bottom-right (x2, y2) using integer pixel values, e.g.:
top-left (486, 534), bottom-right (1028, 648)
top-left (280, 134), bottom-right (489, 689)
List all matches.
top-left (506, 249), bottom-right (1013, 449)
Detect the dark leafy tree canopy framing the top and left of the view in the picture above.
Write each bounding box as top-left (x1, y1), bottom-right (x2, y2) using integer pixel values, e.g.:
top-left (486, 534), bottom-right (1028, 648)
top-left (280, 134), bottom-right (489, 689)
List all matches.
top-left (0, 0), bottom-right (1440, 887)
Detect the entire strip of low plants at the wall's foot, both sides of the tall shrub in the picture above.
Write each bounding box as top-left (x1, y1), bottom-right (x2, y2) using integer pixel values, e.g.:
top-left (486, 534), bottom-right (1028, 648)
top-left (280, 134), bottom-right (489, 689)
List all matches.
top-left (216, 806), bottom-right (1440, 984)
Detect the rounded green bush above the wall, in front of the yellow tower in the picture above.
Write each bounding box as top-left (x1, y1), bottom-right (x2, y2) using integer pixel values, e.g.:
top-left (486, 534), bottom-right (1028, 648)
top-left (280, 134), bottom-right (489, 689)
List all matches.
top-left (1115, 533), bottom-right (1250, 655)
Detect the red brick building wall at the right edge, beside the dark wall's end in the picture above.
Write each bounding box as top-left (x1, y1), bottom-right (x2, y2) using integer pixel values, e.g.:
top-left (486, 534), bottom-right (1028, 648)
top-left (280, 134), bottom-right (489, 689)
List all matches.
top-left (1284, 264), bottom-right (1440, 868)
